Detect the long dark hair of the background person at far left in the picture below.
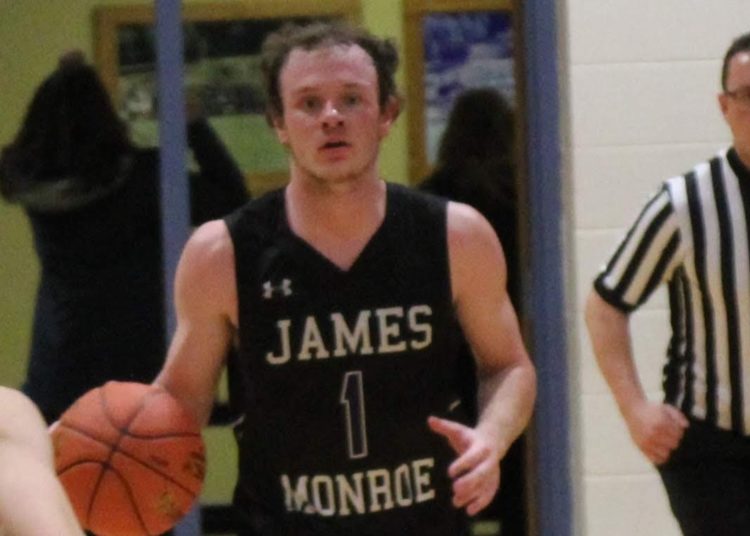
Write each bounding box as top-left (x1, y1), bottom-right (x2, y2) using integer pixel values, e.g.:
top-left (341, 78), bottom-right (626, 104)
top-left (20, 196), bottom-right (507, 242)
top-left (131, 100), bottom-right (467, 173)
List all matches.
top-left (0, 53), bottom-right (132, 199)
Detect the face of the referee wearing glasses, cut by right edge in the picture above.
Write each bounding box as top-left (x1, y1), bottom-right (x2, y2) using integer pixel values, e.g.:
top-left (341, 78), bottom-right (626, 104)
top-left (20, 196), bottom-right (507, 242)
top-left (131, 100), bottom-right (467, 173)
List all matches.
top-left (719, 52), bottom-right (750, 166)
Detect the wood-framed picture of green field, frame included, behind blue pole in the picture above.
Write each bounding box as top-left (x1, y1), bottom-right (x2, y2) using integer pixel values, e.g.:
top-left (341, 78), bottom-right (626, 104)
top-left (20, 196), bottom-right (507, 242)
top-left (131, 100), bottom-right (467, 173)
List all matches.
top-left (94, 0), bottom-right (360, 195)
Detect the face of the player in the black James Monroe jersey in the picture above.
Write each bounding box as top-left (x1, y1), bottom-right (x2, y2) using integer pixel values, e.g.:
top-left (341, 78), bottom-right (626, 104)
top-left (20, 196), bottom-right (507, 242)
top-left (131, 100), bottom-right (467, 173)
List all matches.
top-left (274, 45), bottom-right (396, 187)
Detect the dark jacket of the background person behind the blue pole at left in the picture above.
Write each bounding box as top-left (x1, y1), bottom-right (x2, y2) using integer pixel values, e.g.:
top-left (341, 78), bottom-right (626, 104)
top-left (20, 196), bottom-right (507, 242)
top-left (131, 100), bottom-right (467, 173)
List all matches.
top-left (10, 121), bottom-right (249, 421)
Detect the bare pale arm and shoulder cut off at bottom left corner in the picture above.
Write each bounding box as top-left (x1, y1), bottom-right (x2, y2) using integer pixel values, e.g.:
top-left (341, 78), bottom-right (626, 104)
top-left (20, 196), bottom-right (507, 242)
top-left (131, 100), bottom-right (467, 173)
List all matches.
top-left (0, 386), bottom-right (83, 536)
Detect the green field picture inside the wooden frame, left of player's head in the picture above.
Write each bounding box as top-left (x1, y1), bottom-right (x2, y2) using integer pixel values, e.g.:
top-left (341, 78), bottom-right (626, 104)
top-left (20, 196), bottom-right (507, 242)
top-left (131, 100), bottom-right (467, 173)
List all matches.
top-left (117, 18), bottom-right (310, 172)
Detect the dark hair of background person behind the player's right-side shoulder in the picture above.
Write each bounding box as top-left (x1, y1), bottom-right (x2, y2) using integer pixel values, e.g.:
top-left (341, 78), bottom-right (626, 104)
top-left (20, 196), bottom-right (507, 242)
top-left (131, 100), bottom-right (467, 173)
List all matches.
top-left (436, 88), bottom-right (515, 212)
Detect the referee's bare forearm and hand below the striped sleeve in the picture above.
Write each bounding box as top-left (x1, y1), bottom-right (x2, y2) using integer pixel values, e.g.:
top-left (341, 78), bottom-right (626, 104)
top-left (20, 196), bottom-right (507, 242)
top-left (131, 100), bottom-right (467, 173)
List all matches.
top-left (586, 290), bottom-right (688, 464)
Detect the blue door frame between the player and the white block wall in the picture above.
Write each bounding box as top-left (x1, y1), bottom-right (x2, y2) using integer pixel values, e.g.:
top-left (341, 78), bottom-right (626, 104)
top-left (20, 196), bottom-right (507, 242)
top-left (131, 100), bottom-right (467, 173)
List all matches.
top-left (523, 0), bottom-right (574, 536)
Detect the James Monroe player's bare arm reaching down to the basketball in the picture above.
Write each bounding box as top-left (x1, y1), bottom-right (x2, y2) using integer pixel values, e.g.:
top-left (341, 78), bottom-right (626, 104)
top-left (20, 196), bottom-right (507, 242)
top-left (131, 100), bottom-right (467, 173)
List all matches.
top-left (156, 220), bottom-right (237, 425)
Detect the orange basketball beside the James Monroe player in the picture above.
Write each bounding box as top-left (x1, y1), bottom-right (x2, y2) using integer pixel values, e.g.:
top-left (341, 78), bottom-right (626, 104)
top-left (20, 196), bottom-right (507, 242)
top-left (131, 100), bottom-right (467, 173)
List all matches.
top-left (51, 382), bottom-right (205, 536)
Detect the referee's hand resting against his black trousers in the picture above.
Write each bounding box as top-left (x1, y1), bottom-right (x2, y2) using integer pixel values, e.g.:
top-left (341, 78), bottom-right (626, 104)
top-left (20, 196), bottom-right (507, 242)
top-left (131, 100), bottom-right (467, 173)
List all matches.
top-left (625, 401), bottom-right (690, 465)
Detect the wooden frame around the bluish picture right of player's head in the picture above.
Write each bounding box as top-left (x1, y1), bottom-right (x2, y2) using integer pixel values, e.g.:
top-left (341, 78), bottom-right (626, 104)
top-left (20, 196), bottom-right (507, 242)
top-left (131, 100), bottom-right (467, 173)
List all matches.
top-left (404, 0), bottom-right (522, 184)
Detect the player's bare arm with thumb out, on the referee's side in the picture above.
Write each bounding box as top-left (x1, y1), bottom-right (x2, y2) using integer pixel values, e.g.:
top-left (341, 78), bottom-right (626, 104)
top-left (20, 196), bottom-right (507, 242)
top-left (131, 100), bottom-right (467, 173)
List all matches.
top-left (430, 203), bottom-right (536, 515)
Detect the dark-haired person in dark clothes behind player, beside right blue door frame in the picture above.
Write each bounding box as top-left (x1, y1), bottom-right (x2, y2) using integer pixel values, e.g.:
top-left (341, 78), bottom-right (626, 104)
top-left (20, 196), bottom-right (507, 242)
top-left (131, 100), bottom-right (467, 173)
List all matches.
top-left (419, 87), bottom-right (527, 536)
